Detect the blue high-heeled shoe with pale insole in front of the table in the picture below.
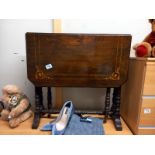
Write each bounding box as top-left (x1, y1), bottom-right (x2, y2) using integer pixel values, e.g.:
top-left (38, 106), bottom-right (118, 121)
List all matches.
top-left (40, 101), bottom-right (74, 135)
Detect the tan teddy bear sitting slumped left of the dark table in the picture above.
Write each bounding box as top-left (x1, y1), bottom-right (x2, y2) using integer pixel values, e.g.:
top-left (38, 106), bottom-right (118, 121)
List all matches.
top-left (0, 85), bottom-right (33, 128)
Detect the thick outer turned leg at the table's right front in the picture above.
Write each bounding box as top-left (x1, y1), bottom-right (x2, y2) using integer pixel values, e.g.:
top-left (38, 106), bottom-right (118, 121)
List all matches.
top-left (111, 87), bottom-right (122, 131)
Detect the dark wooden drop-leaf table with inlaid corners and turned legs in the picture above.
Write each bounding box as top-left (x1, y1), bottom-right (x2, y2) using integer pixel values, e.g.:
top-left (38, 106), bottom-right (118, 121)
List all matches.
top-left (26, 33), bottom-right (131, 130)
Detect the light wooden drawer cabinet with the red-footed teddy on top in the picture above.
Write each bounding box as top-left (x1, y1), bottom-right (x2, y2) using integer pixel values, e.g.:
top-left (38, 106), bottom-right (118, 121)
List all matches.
top-left (121, 58), bottom-right (155, 135)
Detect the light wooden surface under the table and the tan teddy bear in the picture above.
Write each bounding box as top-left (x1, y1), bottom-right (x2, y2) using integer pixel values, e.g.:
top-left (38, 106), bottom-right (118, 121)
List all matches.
top-left (0, 115), bottom-right (132, 135)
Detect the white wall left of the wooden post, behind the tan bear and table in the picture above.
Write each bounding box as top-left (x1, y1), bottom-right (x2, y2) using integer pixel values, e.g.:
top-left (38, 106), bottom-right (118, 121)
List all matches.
top-left (0, 20), bottom-right (52, 106)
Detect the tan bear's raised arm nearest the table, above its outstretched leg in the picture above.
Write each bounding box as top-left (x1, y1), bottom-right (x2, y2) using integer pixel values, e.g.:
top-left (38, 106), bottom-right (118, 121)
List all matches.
top-left (9, 99), bottom-right (29, 118)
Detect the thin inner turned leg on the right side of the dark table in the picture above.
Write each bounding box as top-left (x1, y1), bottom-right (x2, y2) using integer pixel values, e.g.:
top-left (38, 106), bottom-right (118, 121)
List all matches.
top-left (104, 88), bottom-right (110, 123)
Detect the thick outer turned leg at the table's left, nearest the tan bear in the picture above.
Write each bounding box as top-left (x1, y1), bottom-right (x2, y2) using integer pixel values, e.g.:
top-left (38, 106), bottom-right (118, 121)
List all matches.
top-left (32, 87), bottom-right (43, 129)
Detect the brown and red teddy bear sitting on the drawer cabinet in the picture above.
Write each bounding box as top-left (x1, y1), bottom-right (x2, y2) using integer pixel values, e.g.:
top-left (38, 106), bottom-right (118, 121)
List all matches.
top-left (133, 19), bottom-right (155, 57)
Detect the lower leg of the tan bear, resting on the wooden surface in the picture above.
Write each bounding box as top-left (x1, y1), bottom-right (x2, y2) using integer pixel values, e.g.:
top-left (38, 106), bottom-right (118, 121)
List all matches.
top-left (9, 110), bottom-right (32, 128)
